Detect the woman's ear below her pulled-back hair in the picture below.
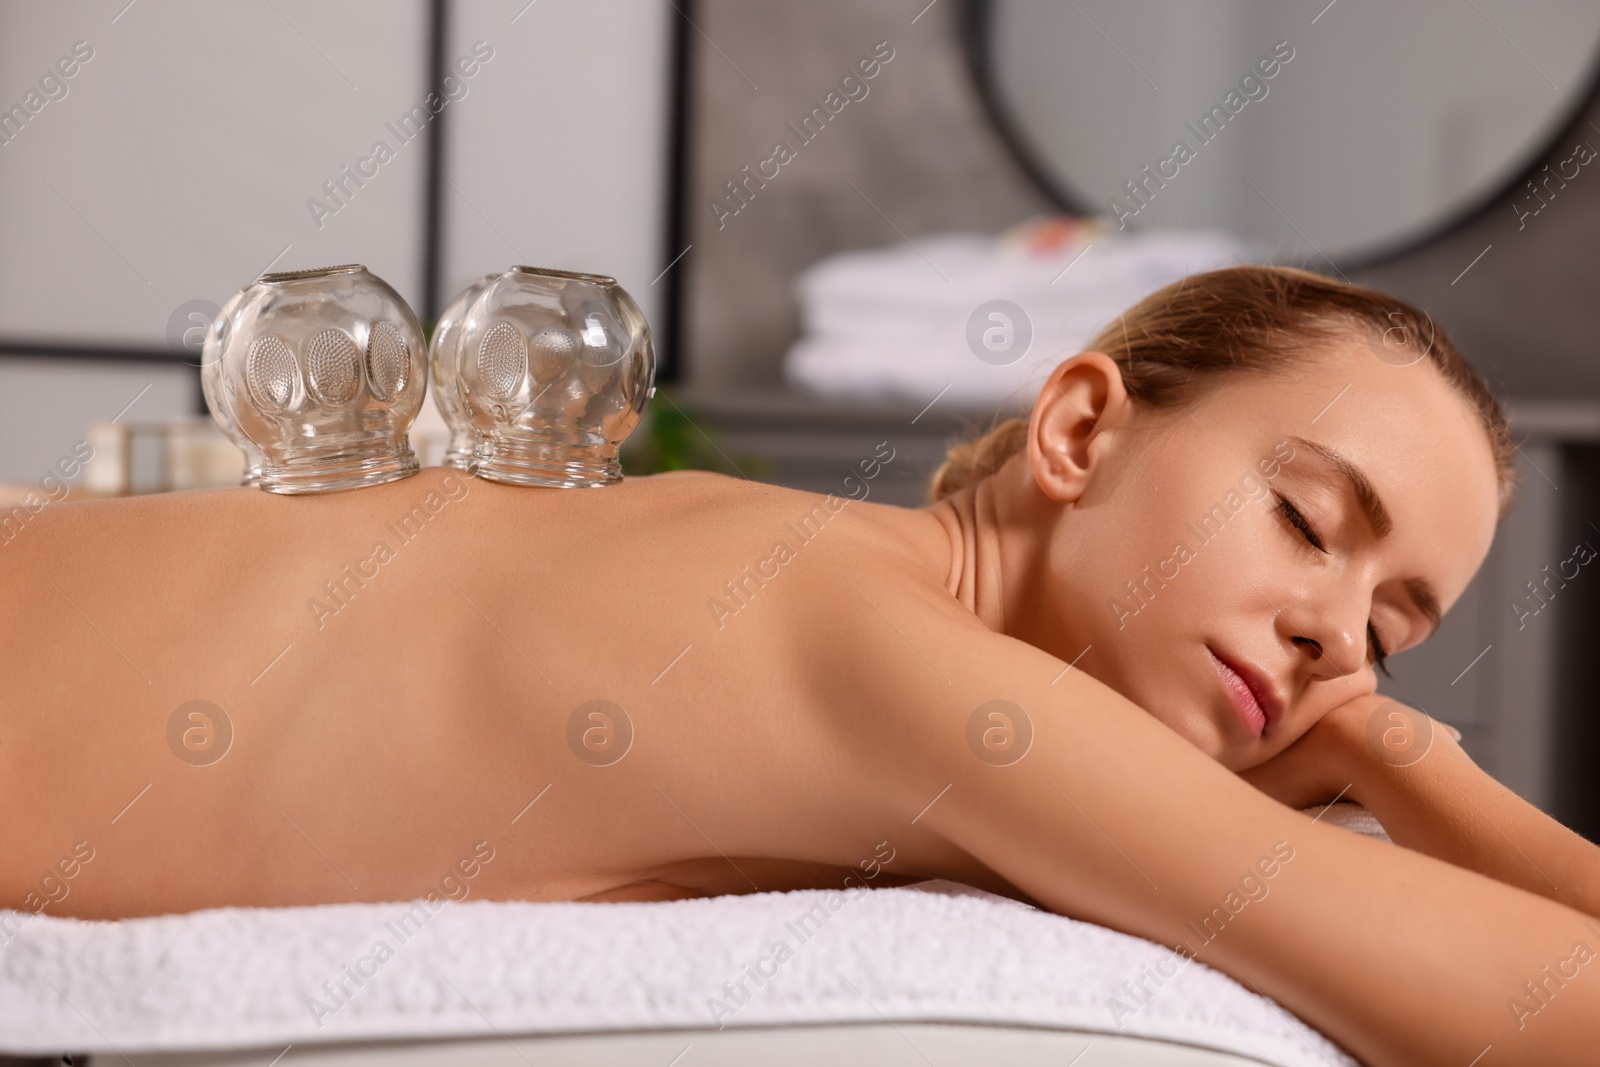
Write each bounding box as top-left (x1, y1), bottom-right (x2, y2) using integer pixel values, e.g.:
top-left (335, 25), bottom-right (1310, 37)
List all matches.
top-left (1027, 352), bottom-right (1133, 504)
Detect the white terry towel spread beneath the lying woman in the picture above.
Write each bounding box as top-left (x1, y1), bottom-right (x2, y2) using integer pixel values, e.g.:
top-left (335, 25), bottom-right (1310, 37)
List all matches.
top-left (0, 851), bottom-right (1376, 1067)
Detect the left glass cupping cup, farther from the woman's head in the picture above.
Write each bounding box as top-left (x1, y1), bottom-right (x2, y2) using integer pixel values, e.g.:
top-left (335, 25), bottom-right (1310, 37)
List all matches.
top-left (202, 264), bottom-right (427, 493)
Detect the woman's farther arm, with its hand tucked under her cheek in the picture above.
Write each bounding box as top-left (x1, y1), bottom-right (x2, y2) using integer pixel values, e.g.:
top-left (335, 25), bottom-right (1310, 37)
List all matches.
top-left (1243, 696), bottom-right (1600, 921)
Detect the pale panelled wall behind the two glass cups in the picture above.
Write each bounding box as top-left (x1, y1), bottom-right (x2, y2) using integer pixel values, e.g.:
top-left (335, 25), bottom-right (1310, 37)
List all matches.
top-left (0, 0), bottom-right (677, 483)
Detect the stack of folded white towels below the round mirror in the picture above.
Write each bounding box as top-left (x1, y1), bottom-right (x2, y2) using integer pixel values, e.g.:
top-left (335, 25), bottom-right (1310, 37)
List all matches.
top-left (784, 218), bottom-right (1262, 406)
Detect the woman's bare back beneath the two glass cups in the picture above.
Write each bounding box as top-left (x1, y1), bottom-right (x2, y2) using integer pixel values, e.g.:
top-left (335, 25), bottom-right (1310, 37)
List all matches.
top-left (0, 469), bottom-right (1006, 917)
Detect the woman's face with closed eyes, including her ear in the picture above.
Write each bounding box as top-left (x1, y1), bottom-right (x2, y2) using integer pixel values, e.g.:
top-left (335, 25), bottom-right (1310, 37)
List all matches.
top-left (1005, 338), bottom-right (1498, 771)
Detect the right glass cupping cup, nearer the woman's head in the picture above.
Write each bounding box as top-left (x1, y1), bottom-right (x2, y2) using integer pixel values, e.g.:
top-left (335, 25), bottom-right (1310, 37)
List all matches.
top-left (429, 267), bottom-right (656, 488)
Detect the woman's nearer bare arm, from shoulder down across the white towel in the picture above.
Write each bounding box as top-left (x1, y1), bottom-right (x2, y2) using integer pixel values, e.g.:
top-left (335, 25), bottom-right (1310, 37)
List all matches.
top-left (810, 591), bottom-right (1600, 1067)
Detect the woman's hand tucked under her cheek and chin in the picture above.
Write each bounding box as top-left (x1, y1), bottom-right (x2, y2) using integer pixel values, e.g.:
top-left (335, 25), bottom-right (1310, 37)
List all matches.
top-left (1238, 693), bottom-right (1459, 808)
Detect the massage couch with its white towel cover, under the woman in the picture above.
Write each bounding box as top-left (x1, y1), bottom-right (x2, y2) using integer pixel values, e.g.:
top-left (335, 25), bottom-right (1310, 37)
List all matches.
top-left (0, 803), bottom-right (1387, 1067)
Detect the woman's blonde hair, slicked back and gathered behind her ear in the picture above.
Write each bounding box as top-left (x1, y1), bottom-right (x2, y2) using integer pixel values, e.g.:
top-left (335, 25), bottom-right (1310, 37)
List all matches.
top-left (930, 266), bottom-right (1517, 517)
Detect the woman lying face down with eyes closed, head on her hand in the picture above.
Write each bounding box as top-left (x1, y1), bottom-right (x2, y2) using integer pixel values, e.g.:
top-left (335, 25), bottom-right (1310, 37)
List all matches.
top-left (0, 267), bottom-right (1600, 1064)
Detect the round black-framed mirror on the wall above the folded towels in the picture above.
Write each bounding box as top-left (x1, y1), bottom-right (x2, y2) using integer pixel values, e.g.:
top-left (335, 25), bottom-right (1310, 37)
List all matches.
top-left (963, 0), bottom-right (1600, 270)
